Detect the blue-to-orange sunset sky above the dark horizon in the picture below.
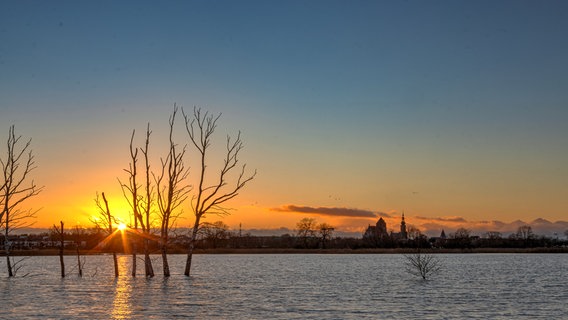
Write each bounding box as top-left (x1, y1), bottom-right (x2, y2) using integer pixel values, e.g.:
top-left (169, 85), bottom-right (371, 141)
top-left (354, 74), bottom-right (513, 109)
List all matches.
top-left (0, 0), bottom-right (568, 234)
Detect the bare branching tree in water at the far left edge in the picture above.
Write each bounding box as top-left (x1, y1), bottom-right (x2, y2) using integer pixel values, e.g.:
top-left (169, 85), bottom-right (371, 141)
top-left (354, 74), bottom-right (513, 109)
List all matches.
top-left (0, 125), bottom-right (43, 277)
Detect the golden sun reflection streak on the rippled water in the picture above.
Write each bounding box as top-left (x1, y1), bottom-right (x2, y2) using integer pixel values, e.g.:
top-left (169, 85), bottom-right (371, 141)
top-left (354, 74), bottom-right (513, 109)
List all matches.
top-left (112, 256), bottom-right (132, 319)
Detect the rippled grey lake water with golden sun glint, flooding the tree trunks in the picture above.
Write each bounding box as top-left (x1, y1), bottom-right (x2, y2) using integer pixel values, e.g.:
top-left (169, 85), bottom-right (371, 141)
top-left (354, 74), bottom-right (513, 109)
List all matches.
top-left (0, 254), bottom-right (568, 319)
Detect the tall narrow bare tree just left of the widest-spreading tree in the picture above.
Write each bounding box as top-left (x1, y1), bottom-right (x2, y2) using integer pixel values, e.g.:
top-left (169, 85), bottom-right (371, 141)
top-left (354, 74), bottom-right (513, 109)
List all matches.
top-left (154, 105), bottom-right (191, 277)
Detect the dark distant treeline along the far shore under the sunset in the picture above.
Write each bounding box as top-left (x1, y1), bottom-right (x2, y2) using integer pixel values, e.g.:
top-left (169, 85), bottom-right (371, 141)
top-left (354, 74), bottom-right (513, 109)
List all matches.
top-left (0, 227), bottom-right (568, 254)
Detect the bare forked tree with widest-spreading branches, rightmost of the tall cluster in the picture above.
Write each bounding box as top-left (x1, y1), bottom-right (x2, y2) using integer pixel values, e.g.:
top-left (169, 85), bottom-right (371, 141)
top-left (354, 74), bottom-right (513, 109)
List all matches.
top-left (182, 108), bottom-right (256, 276)
